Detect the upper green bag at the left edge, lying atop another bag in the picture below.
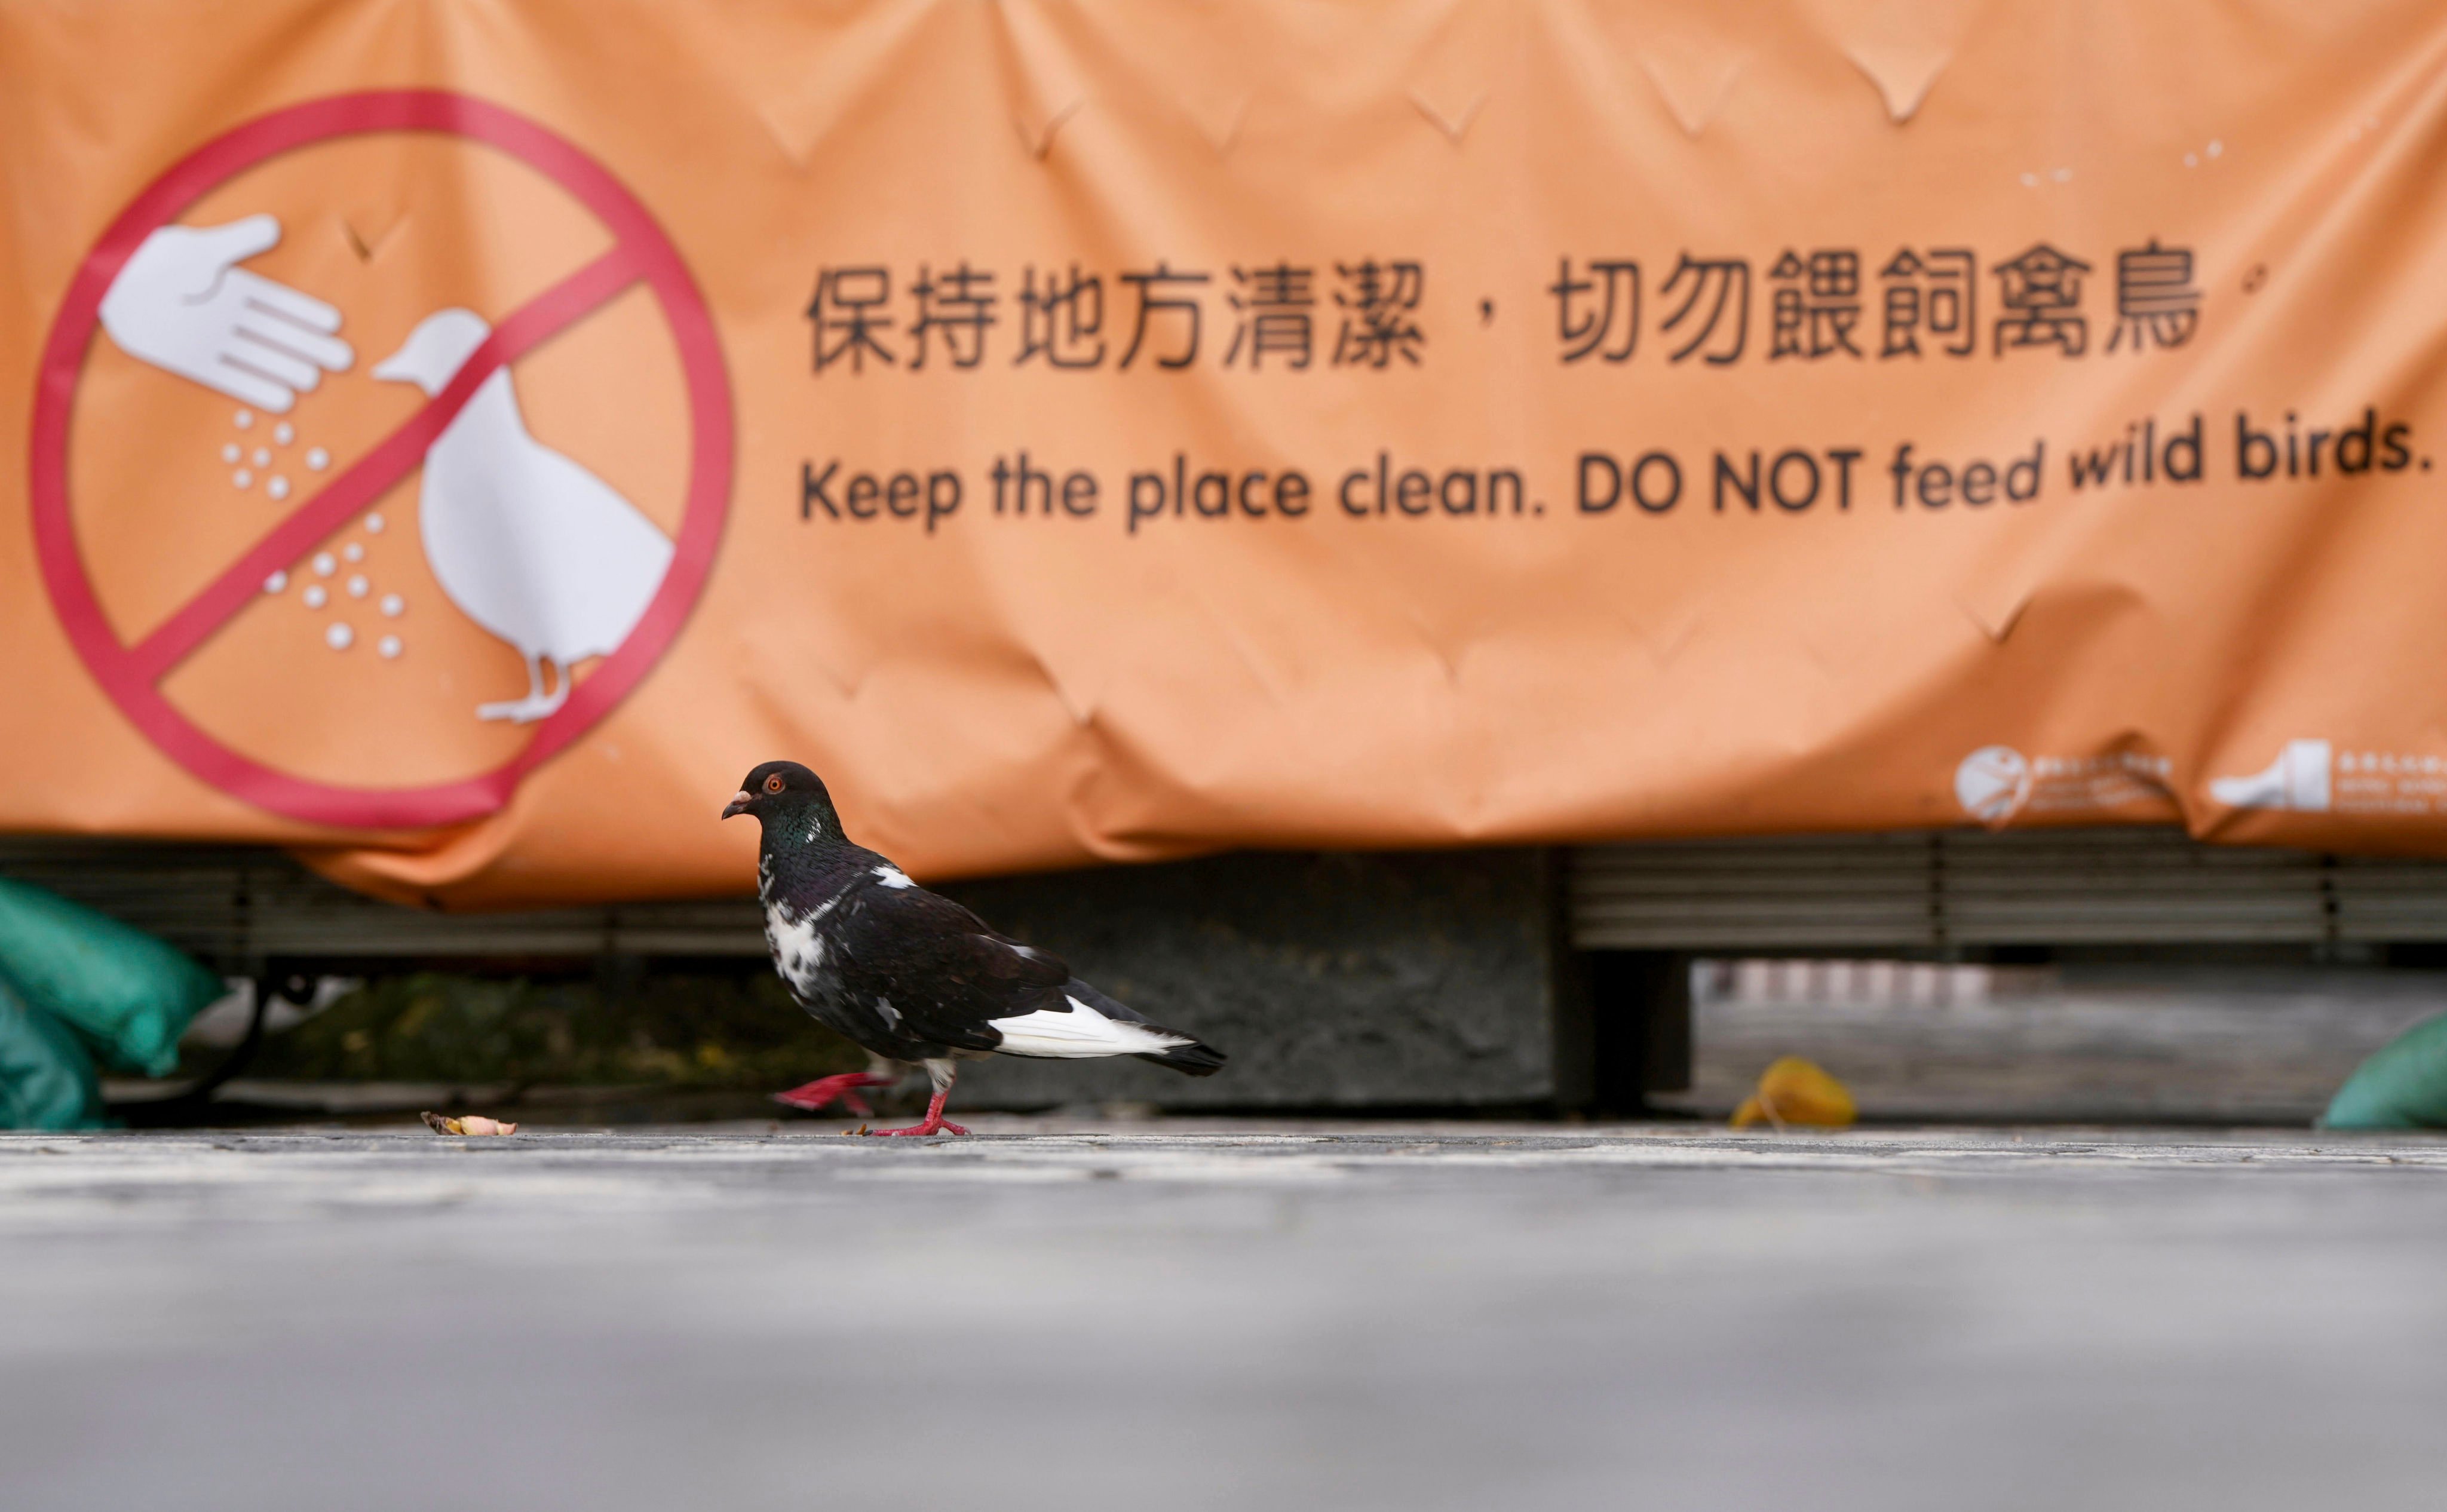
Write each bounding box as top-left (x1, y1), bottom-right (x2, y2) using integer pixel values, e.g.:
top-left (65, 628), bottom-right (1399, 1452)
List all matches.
top-left (0, 876), bottom-right (223, 1077)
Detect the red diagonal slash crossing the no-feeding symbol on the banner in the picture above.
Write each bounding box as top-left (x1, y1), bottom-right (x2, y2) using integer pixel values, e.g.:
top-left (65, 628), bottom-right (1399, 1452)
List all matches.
top-left (127, 242), bottom-right (643, 683)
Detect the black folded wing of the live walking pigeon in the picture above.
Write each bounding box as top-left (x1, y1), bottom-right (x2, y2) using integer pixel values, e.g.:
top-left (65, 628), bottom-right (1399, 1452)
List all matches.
top-left (842, 886), bottom-right (1069, 1050)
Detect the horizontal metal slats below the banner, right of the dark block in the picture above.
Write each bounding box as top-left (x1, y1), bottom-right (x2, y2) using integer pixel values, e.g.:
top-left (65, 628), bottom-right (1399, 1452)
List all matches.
top-left (1571, 829), bottom-right (2447, 949)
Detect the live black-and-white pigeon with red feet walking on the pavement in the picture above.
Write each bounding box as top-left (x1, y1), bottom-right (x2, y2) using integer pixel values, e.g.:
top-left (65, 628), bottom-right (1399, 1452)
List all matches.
top-left (722, 761), bottom-right (1224, 1135)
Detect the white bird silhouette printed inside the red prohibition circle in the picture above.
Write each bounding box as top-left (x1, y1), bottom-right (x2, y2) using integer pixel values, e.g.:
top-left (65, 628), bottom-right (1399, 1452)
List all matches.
top-left (375, 308), bottom-right (670, 724)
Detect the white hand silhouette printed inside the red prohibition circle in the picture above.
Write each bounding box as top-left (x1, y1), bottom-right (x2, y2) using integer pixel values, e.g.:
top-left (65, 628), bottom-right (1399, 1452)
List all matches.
top-left (103, 215), bottom-right (357, 413)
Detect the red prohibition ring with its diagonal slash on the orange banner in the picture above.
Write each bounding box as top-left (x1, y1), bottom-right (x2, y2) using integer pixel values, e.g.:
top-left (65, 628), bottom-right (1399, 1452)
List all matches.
top-left (29, 91), bottom-right (732, 829)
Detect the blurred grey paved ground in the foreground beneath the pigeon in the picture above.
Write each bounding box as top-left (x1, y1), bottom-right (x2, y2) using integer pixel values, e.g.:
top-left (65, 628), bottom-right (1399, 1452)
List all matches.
top-left (0, 1118), bottom-right (2447, 1512)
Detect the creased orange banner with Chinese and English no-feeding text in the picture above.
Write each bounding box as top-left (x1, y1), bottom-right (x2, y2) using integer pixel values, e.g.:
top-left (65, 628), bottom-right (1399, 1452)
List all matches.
top-left (0, 0), bottom-right (2447, 905)
